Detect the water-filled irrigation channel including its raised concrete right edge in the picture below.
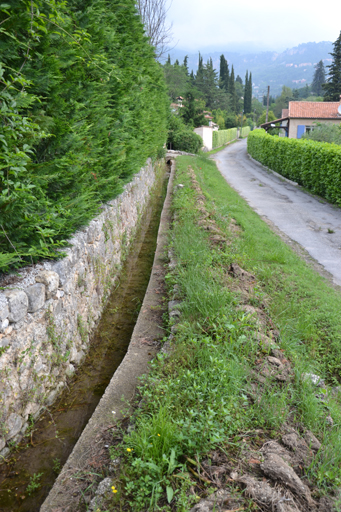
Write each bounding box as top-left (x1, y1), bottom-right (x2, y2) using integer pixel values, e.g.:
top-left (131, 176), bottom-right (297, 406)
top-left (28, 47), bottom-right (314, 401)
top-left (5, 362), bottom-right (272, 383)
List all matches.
top-left (0, 160), bottom-right (175, 512)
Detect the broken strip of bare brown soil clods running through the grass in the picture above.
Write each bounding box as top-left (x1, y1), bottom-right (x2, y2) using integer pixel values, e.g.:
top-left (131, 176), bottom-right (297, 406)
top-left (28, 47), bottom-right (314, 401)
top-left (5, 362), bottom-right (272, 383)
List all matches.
top-left (183, 167), bottom-right (335, 512)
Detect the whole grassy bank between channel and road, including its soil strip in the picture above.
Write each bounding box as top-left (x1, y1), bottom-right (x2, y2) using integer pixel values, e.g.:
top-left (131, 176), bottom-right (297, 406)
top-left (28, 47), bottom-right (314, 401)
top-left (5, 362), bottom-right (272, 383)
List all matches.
top-left (103, 157), bottom-right (341, 512)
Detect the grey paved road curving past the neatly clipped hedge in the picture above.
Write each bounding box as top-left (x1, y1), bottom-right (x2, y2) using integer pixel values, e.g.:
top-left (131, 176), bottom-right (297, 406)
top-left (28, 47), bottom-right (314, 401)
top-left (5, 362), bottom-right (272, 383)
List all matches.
top-left (213, 140), bottom-right (341, 285)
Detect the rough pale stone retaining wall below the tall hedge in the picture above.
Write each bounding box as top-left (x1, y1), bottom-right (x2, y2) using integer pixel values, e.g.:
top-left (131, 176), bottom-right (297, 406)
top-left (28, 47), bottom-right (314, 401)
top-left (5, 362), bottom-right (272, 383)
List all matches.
top-left (0, 160), bottom-right (155, 456)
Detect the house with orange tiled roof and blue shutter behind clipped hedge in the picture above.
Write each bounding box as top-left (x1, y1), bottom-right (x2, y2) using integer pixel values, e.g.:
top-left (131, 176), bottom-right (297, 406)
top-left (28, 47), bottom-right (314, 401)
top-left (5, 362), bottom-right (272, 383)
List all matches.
top-left (261, 97), bottom-right (341, 139)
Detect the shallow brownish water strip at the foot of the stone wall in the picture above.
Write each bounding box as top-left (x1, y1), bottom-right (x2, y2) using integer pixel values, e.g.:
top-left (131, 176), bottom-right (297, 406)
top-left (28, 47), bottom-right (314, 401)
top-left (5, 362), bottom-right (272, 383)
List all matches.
top-left (0, 167), bottom-right (167, 512)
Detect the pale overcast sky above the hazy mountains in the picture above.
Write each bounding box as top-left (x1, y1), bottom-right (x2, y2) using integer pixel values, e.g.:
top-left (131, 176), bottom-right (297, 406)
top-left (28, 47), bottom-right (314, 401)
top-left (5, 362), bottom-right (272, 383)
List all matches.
top-left (168, 0), bottom-right (341, 51)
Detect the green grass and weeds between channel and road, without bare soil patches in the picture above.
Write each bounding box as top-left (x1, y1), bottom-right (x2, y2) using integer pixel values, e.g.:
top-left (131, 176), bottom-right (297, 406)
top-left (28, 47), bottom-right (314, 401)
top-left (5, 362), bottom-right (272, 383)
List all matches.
top-left (109, 157), bottom-right (341, 512)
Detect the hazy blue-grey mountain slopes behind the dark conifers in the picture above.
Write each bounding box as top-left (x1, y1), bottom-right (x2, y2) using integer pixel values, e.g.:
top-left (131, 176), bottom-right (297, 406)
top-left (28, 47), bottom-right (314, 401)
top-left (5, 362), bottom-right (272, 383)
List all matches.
top-left (170, 41), bottom-right (333, 99)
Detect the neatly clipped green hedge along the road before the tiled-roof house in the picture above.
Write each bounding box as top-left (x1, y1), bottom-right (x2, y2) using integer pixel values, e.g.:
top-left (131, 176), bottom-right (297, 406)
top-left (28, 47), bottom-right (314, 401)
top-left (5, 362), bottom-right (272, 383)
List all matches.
top-left (247, 130), bottom-right (341, 205)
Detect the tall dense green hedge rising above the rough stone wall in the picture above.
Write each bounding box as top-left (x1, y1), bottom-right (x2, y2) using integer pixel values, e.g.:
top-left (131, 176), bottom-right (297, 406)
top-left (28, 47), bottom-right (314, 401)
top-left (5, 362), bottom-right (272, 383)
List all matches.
top-left (0, 0), bottom-right (168, 271)
